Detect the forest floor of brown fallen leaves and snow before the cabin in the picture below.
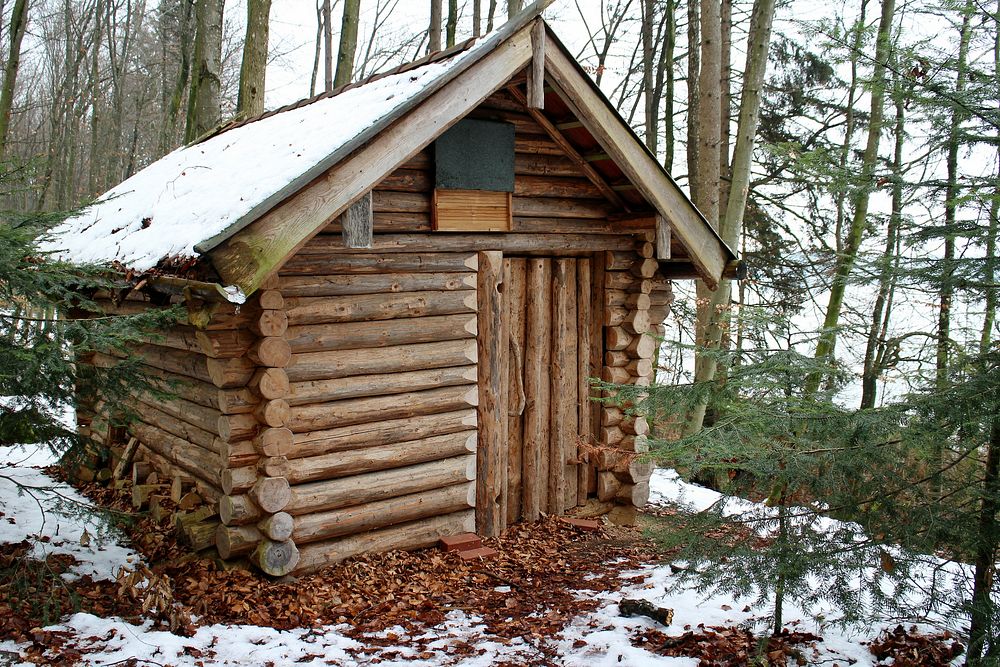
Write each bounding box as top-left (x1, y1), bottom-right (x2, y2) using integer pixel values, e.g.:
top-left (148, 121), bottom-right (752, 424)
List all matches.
top-left (0, 448), bottom-right (960, 667)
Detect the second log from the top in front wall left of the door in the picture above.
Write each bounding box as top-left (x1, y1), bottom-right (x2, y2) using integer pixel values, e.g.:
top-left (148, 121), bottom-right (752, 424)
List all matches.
top-left (281, 273), bottom-right (476, 297)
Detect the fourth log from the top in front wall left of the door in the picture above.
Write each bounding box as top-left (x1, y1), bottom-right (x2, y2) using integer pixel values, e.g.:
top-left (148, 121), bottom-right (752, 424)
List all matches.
top-left (286, 313), bottom-right (477, 354)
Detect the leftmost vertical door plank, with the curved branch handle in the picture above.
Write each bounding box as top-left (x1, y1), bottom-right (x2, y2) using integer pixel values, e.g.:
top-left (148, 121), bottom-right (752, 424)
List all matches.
top-left (503, 259), bottom-right (527, 525)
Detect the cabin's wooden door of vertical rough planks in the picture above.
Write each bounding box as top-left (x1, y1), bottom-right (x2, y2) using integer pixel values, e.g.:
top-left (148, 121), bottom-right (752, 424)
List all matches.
top-left (500, 257), bottom-right (601, 525)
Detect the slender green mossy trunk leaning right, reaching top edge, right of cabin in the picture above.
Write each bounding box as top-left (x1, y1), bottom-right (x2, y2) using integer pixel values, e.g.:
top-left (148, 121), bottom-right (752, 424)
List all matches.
top-left (804, 0), bottom-right (896, 396)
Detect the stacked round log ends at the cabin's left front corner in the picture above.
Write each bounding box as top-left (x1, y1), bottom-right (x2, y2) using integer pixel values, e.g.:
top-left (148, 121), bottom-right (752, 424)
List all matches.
top-left (215, 281), bottom-right (299, 576)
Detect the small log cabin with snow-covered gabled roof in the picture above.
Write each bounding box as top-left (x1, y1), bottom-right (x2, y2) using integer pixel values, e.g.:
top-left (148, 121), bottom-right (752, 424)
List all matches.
top-left (43, 0), bottom-right (738, 575)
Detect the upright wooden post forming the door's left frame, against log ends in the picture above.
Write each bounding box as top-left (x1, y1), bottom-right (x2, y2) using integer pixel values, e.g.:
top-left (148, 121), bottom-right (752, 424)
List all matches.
top-left (476, 250), bottom-right (507, 537)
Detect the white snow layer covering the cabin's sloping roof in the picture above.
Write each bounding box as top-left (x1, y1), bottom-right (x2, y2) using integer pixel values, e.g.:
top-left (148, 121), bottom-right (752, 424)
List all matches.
top-left (42, 45), bottom-right (489, 271)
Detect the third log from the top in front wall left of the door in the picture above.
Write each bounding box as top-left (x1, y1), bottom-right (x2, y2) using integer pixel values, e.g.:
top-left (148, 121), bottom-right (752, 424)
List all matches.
top-left (287, 290), bottom-right (476, 326)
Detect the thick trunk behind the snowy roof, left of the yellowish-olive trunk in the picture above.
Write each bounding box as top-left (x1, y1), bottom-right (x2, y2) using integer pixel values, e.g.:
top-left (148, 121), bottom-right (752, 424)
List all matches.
top-left (184, 0), bottom-right (224, 143)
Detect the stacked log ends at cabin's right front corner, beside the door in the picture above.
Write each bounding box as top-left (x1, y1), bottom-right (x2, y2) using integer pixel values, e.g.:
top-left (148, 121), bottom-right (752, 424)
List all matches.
top-left (595, 242), bottom-right (670, 524)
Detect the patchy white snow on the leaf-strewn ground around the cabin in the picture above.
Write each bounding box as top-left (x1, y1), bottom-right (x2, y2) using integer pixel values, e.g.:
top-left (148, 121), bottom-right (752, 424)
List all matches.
top-left (0, 448), bottom-right (960, 667)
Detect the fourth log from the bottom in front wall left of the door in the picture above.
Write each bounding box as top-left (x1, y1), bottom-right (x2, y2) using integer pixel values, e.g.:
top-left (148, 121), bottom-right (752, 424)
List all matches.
top-left (288, 431), bottom-right (476, 484)
